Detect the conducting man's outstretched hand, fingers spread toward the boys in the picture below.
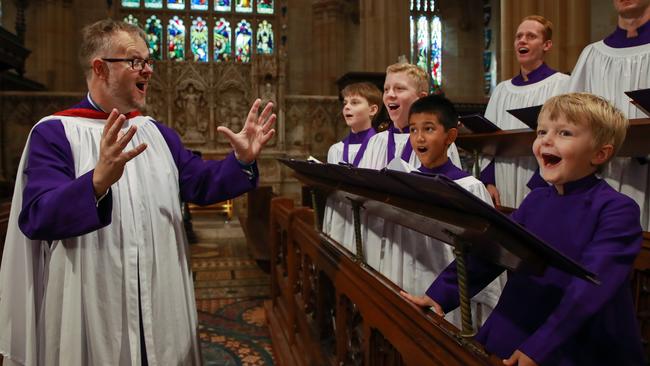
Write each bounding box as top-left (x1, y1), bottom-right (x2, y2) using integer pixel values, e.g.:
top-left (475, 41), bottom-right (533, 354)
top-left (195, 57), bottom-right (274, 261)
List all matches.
top-left (217, 99), bottom-right (276, 164)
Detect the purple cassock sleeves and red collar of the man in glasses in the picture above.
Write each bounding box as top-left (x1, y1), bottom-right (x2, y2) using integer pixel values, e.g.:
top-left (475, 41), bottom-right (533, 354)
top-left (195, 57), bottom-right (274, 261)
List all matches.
top-left (19, 97), bottom-right (259, 241)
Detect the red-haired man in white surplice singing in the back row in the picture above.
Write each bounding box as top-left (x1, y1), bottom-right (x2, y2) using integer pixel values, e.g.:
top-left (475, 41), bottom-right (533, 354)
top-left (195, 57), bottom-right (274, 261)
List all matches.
top-left (481, 15), bottom-right (569, 208)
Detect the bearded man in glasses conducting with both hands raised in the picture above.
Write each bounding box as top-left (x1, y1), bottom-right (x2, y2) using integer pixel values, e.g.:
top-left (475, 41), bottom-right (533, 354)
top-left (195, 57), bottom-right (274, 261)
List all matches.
top-left (0, 19), bottom-right (275, 366)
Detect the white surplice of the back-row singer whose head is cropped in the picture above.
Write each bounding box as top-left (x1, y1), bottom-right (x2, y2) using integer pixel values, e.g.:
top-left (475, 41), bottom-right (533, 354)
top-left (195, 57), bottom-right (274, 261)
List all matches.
top-left (569, 41), bottom-right (650, 230)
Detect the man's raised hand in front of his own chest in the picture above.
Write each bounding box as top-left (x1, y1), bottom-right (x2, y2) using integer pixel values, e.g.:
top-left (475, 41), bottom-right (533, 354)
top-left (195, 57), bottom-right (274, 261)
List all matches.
top-left (93, 109), bottom-right (147, 197)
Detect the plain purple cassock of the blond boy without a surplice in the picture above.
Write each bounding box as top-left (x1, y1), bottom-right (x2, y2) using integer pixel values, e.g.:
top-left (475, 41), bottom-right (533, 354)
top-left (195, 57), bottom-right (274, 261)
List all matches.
top-left (426, 175), bottom-right (645, 365)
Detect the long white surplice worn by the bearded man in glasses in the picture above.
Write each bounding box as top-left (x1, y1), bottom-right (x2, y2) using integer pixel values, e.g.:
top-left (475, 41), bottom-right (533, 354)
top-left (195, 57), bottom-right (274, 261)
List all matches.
top-left (0, 116), bottom-right (201, 366)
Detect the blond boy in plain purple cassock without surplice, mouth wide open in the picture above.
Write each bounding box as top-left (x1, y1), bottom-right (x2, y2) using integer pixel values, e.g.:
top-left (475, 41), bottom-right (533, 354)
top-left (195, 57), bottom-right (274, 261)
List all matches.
top-left (400, 93), bottom-right (645, 366)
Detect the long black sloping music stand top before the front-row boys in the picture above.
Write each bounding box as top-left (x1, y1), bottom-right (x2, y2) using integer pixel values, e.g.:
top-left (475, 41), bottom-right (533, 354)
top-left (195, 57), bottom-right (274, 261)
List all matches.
top-left (278, 159), bottom-right (599, 283)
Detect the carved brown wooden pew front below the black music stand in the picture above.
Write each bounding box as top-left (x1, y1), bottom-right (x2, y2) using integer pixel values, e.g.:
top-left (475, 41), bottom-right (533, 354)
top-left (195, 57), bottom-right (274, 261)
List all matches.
top-left (265, 197), bottom-right (502, 366)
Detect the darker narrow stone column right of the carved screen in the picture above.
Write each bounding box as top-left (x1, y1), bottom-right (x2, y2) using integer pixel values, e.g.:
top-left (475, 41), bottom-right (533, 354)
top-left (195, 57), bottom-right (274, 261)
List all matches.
top-left (312, 0), bottom-right (347, 95)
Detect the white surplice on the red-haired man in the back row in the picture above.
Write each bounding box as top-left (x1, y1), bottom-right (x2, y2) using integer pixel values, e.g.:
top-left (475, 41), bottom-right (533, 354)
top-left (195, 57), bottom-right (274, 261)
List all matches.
top-left (483, 72), bottom-right (569, 208)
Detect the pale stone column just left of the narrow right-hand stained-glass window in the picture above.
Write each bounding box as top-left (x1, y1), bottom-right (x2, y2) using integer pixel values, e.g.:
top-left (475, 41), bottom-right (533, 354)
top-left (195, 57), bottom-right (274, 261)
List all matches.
top-left (360, 0), bottom-right (411, 72)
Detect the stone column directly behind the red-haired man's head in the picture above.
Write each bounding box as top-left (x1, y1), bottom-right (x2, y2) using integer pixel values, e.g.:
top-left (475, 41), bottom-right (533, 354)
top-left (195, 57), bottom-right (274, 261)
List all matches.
top-left (499, 0), bottom-right (591, 81)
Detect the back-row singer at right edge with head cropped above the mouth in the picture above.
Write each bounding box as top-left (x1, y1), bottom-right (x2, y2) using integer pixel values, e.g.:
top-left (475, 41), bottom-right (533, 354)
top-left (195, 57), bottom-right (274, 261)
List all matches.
top-left (569, 0), bottom-right (650, 231)
